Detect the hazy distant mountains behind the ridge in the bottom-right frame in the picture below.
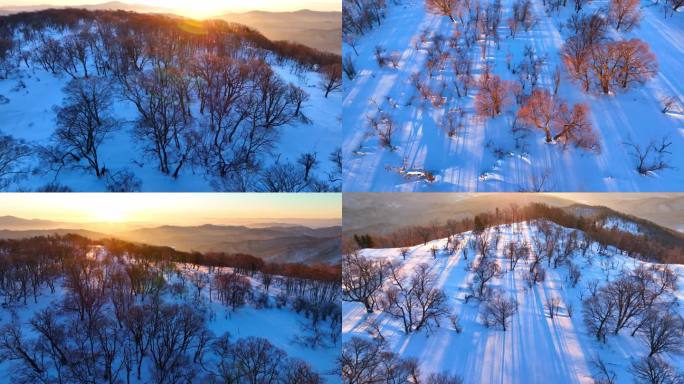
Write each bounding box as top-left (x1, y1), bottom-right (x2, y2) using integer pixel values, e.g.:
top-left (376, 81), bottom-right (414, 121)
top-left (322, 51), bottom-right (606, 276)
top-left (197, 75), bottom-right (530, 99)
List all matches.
top-left (342, 193), bottom-right (684, 235)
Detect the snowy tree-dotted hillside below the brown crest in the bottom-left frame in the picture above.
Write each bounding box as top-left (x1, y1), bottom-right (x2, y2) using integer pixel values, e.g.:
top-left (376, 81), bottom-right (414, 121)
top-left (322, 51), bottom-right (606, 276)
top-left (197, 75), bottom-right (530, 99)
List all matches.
top-left (0, 240), bottom-right (340, 383)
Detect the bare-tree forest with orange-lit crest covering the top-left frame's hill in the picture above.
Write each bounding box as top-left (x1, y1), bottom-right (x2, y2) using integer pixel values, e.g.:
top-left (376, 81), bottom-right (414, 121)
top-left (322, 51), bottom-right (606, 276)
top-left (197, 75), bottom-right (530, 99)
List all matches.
top-left (0, 9), bottom-right (342, 192)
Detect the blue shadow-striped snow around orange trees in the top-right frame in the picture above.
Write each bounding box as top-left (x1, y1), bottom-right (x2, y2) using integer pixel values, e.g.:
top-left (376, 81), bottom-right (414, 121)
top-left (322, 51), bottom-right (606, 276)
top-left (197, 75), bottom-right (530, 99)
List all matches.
top-left (342, 0), bottom-right (684, 192)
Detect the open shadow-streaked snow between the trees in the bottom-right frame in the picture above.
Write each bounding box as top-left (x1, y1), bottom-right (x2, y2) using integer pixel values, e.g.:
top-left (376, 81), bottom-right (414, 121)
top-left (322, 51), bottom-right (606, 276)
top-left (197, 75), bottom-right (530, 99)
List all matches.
top-left (342, 223), bottom-right (684, 384)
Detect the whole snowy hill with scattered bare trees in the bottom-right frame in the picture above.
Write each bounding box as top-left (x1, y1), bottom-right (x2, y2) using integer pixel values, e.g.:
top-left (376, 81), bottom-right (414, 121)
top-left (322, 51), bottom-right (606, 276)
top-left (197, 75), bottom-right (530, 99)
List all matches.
top-left (342, 222), bottom-right (684, 384)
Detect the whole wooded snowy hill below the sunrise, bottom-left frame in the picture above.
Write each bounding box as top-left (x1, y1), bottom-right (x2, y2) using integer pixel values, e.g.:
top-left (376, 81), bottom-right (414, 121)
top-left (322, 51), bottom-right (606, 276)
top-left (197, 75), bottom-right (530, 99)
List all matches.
top-left (0, 235), bottom-right (341, 384)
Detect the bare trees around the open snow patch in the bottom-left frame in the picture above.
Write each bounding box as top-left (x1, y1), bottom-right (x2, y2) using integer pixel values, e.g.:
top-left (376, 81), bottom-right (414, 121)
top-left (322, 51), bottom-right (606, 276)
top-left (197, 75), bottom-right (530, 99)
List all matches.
top-left (0, 235), bottom-right (341, 384)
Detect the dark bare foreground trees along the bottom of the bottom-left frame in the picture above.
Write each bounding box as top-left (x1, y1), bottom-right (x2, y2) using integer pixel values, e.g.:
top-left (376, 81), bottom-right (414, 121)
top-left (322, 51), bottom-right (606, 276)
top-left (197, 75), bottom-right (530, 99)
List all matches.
top-left (0, 302), bottom-right (322, 384)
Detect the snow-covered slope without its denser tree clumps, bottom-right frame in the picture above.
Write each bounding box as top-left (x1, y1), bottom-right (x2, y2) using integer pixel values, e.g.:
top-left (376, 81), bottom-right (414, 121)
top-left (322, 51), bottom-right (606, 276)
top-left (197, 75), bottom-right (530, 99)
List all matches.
top-left (342, 222), bottom-right (684, 384)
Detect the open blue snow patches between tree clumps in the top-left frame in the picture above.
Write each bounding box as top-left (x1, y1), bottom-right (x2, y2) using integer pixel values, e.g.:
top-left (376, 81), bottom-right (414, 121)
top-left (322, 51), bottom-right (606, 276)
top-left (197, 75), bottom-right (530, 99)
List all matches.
top-left (0, 30), bottom-right (342, 192)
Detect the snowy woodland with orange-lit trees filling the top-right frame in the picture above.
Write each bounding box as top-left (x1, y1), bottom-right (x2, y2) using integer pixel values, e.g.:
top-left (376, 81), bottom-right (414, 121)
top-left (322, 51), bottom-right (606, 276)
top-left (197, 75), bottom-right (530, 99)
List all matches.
top-left (342, 0), bottom-right (684, 192)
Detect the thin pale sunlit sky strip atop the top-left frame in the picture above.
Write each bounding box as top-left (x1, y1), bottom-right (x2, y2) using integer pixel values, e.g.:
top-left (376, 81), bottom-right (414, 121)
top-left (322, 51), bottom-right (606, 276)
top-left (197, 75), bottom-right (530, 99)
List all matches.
top-left (0, 0), bottom-right (342, 17)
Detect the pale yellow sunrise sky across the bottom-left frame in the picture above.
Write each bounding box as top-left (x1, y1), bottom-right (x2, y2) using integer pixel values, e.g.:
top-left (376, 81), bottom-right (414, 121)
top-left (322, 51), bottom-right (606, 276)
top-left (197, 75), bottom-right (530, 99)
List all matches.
top-left (0, 193), bottom-right (342, 225)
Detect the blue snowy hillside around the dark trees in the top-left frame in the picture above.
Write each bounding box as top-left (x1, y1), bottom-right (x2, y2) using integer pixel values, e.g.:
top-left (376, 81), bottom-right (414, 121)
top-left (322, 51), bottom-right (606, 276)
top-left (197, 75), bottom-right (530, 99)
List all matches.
top-left (0, 11), bottom-right (341, 191)
